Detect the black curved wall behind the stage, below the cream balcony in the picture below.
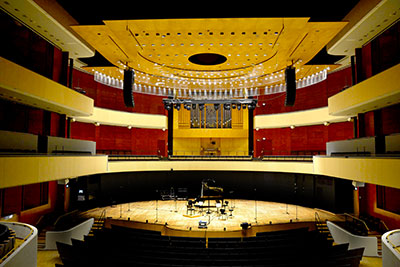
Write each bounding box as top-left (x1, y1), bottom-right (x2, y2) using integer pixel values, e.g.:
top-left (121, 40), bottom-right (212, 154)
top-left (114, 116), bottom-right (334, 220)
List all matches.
top-left (70, 171), bottom-right (353, 213)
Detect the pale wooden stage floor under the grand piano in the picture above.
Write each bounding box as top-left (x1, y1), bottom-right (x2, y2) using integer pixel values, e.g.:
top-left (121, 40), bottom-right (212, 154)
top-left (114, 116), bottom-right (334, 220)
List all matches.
top-left (84, 199), bottom-right (342, 231)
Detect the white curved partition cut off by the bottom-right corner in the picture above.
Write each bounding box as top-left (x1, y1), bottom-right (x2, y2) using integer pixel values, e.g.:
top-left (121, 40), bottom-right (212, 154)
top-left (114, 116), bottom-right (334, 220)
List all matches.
top-left (382, 229), bottom-right (400, 267)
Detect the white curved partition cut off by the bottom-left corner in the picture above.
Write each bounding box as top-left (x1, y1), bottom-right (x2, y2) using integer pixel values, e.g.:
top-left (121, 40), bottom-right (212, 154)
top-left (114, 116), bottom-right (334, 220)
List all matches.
top-left (0, 221), bottom-right (38, 267)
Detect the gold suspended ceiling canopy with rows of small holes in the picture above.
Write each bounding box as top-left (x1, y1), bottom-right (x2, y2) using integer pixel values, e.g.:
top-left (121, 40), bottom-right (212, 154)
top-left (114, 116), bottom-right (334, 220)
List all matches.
top-left (73, 18), bottom-right (347, 89)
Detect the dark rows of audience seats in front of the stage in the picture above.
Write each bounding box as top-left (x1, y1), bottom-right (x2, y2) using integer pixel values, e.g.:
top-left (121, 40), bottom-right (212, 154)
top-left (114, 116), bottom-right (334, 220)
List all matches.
top-left (57, 226), bottom-right (364, 267)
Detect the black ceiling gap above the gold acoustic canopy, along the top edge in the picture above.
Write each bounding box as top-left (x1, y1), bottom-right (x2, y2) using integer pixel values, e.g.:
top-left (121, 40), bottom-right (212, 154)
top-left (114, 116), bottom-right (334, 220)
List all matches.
top-left (57, 0), bottom-right (359, 25)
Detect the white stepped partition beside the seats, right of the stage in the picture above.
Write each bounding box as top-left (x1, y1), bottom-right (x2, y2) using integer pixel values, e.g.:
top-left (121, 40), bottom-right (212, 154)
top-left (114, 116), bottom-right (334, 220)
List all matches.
top-left (326, 221), bottom-right (380, 257)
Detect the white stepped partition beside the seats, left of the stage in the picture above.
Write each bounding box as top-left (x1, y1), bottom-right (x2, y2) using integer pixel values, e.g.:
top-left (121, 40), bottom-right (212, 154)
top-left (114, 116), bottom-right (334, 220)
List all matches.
top-left (45, 218), bottom-right (94, 250)
